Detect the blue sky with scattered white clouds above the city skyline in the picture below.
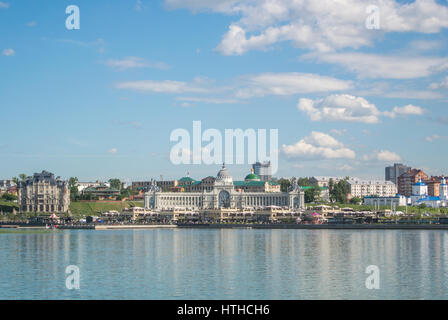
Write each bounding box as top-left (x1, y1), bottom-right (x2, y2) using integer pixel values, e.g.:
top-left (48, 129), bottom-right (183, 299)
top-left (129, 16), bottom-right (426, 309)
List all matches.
top-left (0, 0), bottom-right (448, 182)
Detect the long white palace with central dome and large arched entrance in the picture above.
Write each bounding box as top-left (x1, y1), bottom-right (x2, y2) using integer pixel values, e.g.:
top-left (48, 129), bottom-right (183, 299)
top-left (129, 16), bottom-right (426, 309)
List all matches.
top-left (145, 165), bottom-right (305, 211)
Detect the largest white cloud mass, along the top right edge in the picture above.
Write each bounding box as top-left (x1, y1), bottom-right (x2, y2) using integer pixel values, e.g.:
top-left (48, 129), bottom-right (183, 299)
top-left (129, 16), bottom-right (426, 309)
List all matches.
top-left (165, 0), bottom-right (448, 55)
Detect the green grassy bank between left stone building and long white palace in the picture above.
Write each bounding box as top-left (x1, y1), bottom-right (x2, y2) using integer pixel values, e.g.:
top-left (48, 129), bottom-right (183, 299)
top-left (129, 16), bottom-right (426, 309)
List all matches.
top-left (70, 201), bottom-right (143, 217)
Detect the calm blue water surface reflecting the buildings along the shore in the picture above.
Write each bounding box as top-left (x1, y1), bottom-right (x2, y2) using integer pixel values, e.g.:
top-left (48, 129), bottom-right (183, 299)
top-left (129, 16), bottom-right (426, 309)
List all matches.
top-left (0, 229), bottom-right (448, 299)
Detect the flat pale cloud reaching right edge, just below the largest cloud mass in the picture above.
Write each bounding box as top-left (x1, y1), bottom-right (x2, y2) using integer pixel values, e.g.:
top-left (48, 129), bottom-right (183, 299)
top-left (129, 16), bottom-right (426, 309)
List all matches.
top-left (302, 53), bottom-right (448, 79)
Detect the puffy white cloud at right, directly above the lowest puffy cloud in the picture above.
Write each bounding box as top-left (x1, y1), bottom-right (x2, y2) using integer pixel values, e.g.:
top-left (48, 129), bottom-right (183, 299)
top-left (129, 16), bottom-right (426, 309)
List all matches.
top-left (297, 94), bottom-right (380, 123)
